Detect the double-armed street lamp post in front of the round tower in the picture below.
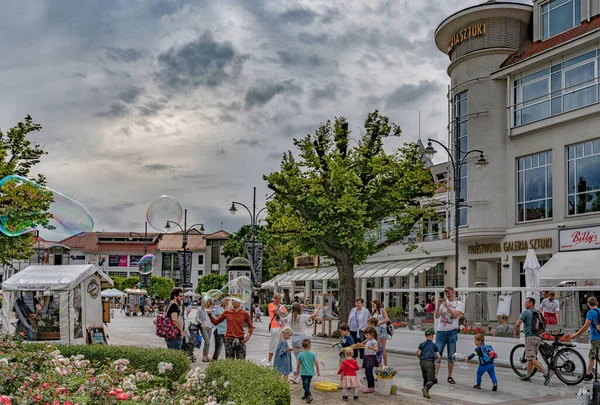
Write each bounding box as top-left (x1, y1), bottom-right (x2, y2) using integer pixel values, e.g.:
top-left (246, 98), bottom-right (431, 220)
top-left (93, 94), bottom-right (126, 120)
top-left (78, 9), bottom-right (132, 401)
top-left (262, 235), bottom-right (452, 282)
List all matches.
top-left (424, 139), bottom-right (489, 288)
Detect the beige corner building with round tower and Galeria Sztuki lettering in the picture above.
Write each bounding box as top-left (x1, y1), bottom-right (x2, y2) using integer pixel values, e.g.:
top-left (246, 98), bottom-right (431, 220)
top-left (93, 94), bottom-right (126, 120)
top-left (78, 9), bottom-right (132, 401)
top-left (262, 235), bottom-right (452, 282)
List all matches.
top-left (435, 0), bottom-right (600, 312)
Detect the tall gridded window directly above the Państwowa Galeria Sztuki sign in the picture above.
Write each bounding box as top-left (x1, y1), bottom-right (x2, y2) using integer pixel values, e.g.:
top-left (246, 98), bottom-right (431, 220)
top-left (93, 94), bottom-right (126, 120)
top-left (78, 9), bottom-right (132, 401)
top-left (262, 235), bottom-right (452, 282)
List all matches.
top-left (517, 151), bottom-right (552, 222)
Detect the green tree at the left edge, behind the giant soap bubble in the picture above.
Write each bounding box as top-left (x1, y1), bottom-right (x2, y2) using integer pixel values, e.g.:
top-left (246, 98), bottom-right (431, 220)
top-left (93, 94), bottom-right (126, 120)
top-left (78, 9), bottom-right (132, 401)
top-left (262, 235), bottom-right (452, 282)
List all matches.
top-left (0, 115), bottom-right (52, 266)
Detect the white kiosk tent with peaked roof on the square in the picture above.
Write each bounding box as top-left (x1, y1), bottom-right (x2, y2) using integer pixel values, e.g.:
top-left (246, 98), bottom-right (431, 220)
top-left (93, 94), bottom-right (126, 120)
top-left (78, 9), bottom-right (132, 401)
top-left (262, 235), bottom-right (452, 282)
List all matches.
top-left (2, 264), bottom-right (114, 344)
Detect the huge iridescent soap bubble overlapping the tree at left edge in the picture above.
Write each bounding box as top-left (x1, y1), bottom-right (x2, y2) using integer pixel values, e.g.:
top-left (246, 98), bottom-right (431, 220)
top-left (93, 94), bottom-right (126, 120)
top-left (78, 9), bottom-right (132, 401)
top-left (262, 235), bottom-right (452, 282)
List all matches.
top-left (0, 175), bottom-right (94, 236)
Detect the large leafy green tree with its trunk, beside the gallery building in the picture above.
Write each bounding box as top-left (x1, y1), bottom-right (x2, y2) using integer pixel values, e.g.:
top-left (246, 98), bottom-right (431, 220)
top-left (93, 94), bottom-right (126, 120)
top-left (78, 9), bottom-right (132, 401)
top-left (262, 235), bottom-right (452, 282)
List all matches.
top-left (264, 111), bottom-right (435, 319)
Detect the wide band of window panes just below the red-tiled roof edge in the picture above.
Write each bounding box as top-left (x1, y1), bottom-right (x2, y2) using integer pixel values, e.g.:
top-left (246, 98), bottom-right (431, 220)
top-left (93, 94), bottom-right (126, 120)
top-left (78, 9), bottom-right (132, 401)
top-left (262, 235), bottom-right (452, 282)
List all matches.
top-left (513, 46), bottom-right (599, 126)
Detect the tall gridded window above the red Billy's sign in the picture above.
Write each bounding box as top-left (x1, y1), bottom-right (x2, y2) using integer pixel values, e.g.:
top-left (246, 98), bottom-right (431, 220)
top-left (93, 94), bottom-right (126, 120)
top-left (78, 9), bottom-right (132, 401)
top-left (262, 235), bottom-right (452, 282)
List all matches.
top-left (567, 139), bottom-right (600, 215)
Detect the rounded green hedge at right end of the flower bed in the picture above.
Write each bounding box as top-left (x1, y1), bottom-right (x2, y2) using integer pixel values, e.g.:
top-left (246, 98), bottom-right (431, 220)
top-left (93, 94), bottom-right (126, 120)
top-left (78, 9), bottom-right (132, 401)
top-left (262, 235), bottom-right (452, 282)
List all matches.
top-left (206, 360), bottom-right (291, 405)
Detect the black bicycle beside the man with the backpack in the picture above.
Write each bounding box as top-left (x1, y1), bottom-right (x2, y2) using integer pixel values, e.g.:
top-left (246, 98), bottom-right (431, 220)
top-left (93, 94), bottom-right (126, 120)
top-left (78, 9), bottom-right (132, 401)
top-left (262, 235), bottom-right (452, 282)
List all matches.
top-left (510, 333), bottom-right (587, 385)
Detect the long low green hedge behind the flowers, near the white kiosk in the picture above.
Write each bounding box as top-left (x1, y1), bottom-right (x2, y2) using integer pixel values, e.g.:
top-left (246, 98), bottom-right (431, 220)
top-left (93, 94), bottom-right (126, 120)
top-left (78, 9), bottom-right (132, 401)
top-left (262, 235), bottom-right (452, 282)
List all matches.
top-left (23, 343), bottom-right (190, 381)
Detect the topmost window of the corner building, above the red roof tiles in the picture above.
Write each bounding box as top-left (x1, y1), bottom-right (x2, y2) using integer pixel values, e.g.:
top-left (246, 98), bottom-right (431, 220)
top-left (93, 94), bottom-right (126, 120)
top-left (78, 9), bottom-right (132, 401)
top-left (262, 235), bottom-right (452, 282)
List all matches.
top-left (542, 0), bottom-right (581, 39)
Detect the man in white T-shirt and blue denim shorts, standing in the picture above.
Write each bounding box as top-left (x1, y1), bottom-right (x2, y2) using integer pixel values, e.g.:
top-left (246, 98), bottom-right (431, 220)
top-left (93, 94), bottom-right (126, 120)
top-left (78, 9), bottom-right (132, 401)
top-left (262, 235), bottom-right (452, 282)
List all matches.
top-left (435, 286), bottom-right (464, 384)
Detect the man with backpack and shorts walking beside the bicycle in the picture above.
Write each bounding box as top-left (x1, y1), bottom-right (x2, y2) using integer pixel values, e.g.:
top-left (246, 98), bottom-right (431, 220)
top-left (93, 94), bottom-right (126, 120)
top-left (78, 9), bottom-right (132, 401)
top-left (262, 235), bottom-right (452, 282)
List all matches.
top-left (515, 297), bottom-right (550, 385)
